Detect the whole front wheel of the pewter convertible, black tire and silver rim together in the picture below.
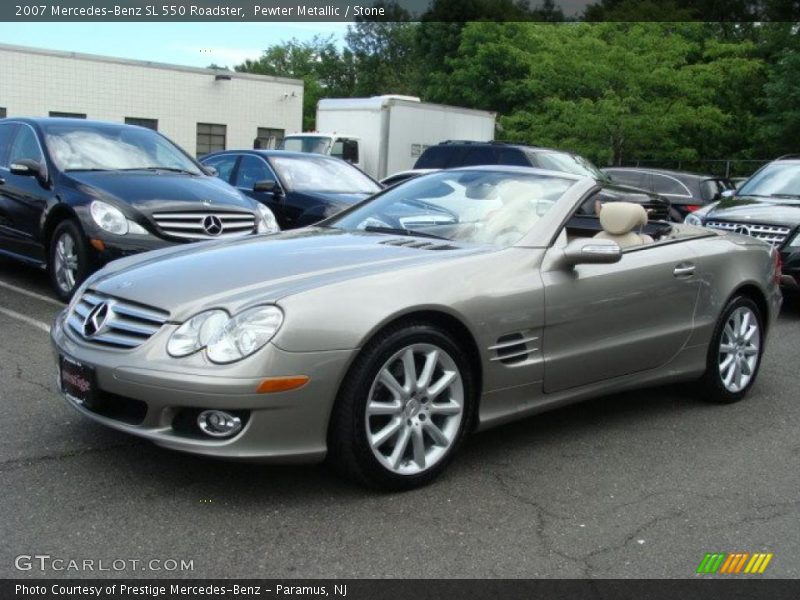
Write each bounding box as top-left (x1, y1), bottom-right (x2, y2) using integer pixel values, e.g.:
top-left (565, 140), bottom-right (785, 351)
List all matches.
top-left (328, 322), bottom-right (476, 491)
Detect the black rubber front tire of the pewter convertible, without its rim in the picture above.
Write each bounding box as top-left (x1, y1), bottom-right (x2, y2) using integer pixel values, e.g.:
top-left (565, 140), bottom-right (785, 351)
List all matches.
top-left (331, 323), bottom-right (476, 490)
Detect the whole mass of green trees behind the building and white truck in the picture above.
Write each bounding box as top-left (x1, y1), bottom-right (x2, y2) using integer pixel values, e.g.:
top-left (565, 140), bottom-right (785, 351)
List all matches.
top-left (236, 18), bottom-right (800, 164)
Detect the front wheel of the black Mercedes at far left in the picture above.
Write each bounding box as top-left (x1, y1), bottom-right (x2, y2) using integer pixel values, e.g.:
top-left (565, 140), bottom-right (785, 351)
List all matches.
top-left (47, 220), bottom-right (89, 302)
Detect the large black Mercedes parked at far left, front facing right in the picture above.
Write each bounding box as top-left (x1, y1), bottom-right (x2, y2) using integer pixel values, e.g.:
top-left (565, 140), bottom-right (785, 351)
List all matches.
top-left (0, 118), bottom-right (278, 301)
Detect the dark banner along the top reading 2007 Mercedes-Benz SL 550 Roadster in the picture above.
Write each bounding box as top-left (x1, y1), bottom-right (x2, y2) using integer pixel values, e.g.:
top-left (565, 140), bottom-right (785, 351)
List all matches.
top-left (0, 0), bottom-right (800, 22)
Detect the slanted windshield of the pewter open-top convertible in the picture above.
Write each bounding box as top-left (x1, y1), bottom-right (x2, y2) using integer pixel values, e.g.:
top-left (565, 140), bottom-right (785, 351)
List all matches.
top-left (326, 170), bottom-right (574, 247)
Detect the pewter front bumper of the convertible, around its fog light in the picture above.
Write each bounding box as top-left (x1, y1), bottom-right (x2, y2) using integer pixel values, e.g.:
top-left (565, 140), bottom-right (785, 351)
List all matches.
top-left (50, 311), bottom-right (355, 463)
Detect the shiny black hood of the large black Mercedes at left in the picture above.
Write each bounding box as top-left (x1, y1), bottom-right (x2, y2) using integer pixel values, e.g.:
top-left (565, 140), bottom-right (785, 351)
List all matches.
top-left (66, 171), bottom-right (254, 213)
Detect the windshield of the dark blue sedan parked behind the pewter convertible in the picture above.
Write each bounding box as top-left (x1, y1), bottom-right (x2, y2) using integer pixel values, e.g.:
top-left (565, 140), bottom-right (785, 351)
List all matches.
top-left (270, 156), bottom-right (381, 194)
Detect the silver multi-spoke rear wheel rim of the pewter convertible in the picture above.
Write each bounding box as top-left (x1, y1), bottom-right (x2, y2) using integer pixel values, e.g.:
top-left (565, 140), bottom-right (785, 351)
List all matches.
top-left (719, 306), bottom-right (761, 393)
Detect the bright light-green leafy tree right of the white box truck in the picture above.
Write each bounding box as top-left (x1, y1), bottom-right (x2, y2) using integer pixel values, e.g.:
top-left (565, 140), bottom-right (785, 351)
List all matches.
top-left (439, 23), bottom-right (757, 164)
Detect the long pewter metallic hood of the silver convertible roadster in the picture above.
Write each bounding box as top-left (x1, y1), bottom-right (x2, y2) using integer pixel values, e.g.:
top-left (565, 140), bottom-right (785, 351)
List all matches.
top-left (89, 228), bottom-right (488, 321)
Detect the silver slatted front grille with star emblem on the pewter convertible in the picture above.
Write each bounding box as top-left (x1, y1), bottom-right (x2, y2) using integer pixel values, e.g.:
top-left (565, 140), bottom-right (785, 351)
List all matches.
top-left (67, 291), bottom-right (169, 348)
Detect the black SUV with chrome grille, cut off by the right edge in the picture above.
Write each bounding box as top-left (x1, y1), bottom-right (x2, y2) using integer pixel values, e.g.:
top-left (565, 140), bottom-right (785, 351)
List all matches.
top-left (686, 158), bottom-right (800, 290)
